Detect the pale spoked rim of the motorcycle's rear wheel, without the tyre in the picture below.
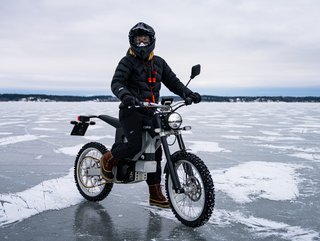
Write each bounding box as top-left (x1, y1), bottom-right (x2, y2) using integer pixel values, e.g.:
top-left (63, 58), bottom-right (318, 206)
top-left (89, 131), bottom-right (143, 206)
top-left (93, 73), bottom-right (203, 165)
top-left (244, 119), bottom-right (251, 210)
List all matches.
top-left (77, 148), bottom-right (106, 197)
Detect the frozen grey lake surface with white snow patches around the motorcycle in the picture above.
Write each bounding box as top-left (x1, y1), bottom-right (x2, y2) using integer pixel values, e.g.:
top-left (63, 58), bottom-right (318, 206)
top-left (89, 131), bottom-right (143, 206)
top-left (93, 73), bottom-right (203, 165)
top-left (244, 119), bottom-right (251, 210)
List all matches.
top-left (0, 102), bottom-right (320, 240)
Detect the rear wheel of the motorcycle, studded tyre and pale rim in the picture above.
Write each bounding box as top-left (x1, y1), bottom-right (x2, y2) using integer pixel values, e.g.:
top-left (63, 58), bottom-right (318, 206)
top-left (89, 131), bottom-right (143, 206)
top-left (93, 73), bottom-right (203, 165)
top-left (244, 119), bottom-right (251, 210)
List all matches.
top-left (74, 142), bottom-right (113, 201)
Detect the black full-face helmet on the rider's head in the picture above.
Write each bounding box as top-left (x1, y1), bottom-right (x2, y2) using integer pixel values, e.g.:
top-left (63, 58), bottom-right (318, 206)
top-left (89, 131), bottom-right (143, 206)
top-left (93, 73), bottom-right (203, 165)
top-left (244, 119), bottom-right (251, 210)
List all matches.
top-left (129, 22), bottom-right (156, 59)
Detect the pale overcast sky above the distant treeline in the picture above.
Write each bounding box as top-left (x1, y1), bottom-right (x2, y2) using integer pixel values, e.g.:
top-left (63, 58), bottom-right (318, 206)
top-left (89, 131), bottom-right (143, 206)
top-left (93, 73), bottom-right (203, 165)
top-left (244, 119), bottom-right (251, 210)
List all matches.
top-left (0, 0), bottom-right (320, 96)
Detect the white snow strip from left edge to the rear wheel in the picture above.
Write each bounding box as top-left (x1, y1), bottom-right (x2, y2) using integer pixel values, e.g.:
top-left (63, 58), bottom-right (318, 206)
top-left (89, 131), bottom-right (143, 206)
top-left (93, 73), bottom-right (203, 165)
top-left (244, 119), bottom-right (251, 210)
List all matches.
top-left (0, 168), bottom-right (83, 226)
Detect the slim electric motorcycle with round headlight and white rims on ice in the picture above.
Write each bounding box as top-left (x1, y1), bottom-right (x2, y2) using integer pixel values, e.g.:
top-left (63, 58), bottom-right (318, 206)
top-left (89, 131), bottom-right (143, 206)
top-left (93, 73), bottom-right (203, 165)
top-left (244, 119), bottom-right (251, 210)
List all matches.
top-left (71, 65), bottom-right (215, 227)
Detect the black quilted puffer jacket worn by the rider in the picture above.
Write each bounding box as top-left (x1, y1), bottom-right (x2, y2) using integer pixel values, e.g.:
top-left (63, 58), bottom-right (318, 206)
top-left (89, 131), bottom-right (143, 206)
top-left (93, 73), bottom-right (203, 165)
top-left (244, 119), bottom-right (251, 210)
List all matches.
top-left (111, 51), bottom-right (192, 102)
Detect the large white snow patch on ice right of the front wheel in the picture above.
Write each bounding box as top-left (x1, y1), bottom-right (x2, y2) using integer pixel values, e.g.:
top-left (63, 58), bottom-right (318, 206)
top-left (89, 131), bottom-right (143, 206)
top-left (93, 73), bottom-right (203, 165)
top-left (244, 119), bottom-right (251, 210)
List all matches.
top-left (211, 161), bottom-right (304, 203)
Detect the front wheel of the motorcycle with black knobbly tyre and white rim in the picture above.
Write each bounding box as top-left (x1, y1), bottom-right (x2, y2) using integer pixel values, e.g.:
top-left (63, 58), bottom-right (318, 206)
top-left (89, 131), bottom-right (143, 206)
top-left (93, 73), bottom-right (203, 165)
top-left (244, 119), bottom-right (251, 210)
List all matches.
top-left (166, 152), bottom-right (215, 227)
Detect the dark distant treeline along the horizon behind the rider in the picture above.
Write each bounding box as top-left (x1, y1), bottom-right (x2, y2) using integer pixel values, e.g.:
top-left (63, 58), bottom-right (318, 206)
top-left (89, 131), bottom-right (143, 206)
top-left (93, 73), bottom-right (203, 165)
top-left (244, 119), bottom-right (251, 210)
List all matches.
top-left (0, 94), bottom-right (320, 102)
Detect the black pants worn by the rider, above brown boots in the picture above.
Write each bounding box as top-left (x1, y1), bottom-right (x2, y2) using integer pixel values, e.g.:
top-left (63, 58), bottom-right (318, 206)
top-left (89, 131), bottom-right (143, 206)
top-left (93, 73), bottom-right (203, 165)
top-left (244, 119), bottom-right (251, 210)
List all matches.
top-left (111, 108), bottom-right (162, 185)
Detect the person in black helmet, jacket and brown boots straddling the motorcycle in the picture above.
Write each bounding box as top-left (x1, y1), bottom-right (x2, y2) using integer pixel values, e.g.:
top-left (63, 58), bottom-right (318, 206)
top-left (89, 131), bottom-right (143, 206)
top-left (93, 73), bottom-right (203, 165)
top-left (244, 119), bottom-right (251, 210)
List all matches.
top-left (101, 22), bottom-right (201, 208)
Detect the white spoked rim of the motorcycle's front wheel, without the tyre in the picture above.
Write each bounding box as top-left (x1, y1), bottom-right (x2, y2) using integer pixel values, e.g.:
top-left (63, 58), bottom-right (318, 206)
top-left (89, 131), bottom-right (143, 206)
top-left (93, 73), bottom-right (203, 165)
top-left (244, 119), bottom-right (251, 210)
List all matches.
top-left (168, 160), bottom-right (205, 221)
